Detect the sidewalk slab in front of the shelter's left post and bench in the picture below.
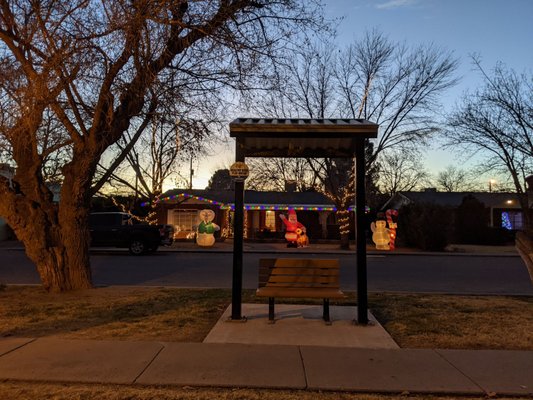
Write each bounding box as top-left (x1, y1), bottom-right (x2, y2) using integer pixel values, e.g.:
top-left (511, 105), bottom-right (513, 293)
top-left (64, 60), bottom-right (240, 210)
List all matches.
top-left (137, 343), bottom-right (305, 389)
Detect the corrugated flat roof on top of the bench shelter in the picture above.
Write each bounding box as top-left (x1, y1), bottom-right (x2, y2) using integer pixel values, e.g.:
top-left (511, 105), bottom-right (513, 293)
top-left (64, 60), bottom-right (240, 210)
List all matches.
top-left (230, 118), bottom-right (378, 158)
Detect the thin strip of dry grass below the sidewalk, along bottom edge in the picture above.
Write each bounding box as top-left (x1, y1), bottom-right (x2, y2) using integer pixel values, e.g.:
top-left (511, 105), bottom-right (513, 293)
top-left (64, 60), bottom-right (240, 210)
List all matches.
top-left (0, 382), bottom-right (521, 400)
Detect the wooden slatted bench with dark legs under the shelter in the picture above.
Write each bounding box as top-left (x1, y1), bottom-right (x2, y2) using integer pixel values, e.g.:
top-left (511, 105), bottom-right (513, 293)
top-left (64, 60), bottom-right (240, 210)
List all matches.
top-left (256, 258), bottom-right (346, 325)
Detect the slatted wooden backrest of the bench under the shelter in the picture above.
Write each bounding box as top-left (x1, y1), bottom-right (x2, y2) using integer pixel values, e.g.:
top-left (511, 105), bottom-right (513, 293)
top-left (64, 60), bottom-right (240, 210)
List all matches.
top-left (259, 258), bottom-right (339, 289)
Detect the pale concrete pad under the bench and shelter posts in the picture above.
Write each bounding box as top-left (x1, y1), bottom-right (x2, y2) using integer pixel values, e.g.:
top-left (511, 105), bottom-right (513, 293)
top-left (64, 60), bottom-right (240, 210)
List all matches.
top-left (204, 304), bottom-right (398, 349)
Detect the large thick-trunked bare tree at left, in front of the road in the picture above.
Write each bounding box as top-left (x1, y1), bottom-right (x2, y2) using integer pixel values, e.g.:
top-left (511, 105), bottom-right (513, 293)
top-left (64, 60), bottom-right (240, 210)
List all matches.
top-left (0, 0), bottom-right (321, 292)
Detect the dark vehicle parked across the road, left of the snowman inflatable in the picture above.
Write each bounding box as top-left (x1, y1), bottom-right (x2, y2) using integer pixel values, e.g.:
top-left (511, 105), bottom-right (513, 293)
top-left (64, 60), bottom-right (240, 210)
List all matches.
top-left (89, 212), bottom-right (174, 255)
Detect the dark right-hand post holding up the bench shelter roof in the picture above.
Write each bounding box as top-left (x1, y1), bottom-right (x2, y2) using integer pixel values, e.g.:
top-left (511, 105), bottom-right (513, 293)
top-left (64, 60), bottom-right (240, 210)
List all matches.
top-left (355, 139), bottom-right (368, 325)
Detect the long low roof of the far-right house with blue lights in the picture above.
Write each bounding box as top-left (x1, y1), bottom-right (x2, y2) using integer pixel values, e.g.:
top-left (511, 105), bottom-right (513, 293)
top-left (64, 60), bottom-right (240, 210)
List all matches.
top-left (383, 190), bottom-right (520, 209)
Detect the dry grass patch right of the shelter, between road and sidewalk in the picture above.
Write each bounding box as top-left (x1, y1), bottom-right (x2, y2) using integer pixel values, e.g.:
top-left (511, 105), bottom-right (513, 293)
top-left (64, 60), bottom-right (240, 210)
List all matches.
top-left (369, 293), bottom-right (533, 350)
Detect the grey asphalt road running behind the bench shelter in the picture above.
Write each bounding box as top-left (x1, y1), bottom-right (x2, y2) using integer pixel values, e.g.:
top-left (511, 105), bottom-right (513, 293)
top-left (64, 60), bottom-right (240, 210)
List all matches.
top-left (0, 249), bottom-right (533, 295)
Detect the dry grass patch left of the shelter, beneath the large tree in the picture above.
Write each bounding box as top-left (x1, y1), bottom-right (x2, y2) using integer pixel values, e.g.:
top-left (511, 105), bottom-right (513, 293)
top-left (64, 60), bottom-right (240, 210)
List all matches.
top-left (0, 287), bottom-right (239, 342)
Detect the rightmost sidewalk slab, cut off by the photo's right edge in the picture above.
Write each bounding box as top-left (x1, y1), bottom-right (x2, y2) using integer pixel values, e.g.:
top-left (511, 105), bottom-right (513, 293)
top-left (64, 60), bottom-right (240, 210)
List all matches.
top-left (437, 350), bottom-right (533, 395)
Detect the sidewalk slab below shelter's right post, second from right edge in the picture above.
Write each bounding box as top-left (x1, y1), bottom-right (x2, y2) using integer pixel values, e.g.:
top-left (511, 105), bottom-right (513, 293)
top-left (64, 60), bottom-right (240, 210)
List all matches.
top-left (300, 347), bottom-right (483, 394)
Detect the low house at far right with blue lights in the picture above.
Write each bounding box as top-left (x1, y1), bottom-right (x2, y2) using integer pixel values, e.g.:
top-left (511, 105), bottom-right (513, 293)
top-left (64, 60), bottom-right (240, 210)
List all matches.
top-left (382, 189), bottom-right (524, 230)
